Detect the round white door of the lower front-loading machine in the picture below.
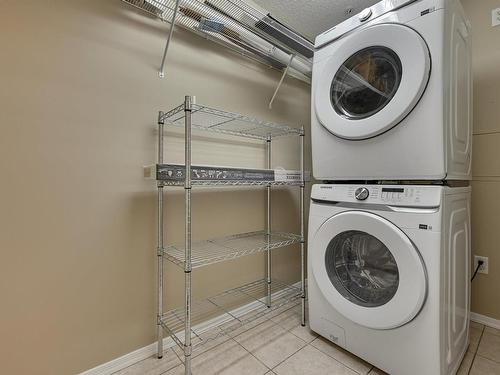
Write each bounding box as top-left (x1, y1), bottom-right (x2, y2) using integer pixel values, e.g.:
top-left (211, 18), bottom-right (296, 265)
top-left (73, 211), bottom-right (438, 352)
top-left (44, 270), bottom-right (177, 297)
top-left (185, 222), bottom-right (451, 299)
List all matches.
top-left (309, 211), bottom-right (427, 329)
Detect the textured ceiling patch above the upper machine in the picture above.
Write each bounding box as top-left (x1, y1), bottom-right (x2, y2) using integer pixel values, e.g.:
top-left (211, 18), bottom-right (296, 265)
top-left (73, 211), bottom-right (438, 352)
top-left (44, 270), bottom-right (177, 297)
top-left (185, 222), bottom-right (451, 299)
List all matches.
top-left (248, 0), bottom-right (379, 41)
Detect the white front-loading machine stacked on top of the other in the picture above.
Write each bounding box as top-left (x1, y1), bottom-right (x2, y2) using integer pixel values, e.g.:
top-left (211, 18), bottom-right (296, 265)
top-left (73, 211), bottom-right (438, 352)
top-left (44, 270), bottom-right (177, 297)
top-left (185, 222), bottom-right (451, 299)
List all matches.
top-left (311, 0), bottom-right (472, 180)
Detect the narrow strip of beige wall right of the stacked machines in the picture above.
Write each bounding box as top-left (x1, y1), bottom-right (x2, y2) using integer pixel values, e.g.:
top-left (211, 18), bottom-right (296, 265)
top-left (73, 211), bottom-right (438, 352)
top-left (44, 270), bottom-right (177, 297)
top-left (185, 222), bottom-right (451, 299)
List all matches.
top-left (462, 0), bottom-right (500, 319)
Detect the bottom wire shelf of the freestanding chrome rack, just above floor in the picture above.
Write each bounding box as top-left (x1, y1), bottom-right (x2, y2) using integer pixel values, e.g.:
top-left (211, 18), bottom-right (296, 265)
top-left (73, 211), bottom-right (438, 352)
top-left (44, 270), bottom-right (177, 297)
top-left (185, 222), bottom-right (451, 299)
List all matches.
top-left (160, 280), bottom-right (302, 350)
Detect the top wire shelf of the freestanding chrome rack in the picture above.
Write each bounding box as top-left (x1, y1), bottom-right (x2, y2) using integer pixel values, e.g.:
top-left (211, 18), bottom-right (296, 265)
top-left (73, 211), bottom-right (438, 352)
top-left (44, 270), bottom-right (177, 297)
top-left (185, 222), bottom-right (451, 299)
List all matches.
top-left (160, 104), bottom-right (303, 140)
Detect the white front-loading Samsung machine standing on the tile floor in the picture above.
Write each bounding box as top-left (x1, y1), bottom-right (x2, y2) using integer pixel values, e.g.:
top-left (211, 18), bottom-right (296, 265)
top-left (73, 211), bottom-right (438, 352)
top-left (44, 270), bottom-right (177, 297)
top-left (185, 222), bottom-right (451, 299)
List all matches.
top-left (308, 184), bottom-right (471, 375)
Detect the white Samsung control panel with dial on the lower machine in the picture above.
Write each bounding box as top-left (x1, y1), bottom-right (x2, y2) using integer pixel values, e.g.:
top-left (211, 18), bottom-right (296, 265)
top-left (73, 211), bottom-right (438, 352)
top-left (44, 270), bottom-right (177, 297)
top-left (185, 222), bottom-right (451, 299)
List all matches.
top-left (311, 184), bottom-right (443, 208)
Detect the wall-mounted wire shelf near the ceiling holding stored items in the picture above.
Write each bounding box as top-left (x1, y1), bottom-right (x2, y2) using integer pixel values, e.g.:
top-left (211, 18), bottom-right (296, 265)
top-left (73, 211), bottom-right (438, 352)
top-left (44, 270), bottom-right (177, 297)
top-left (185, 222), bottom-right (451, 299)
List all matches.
top-left (123, 0), bottom-right (314, 81)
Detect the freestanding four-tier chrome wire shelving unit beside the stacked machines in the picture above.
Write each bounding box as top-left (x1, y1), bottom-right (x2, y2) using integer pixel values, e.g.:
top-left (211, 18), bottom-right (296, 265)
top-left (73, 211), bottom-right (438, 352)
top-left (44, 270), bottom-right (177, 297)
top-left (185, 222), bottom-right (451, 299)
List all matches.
top-left (156, 96), bottom-right (306, 375)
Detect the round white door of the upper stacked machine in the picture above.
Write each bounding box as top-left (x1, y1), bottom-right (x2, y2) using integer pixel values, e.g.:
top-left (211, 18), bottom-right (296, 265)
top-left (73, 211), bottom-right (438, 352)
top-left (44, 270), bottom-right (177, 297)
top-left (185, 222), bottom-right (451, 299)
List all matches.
top-left (315, 24), bottom-right (431, 140)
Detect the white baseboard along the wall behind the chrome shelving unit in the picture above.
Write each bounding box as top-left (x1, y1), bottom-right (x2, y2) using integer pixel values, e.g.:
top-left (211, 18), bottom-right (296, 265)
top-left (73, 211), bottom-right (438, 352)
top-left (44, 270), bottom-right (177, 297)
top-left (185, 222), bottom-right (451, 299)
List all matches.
top-left (79, 282), bottom-right (300, 375)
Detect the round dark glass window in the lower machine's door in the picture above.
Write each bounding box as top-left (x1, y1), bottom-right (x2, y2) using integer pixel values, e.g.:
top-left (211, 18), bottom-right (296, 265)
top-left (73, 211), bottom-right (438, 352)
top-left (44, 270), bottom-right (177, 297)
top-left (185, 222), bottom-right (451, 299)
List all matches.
top-left (325, 230), bottom-right (399, 307)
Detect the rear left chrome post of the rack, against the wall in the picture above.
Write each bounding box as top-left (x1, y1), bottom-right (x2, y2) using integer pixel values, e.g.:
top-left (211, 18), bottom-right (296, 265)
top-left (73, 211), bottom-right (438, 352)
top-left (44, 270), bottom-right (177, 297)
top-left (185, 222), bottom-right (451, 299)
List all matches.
top-left (156, 111), bottom-right (165, 358)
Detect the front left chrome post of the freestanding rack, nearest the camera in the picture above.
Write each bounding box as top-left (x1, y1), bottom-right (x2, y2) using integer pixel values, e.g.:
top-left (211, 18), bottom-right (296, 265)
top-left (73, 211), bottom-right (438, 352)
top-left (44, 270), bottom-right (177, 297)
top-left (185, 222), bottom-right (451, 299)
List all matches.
top-left (184, 96), bottom-right (193, 375)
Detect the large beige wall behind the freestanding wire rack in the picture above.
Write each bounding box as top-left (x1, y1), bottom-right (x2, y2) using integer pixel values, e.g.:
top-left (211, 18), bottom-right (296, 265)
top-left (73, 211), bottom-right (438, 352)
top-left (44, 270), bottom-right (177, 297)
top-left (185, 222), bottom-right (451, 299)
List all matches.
top-left (0, 0), bottom-right (310, 375)
